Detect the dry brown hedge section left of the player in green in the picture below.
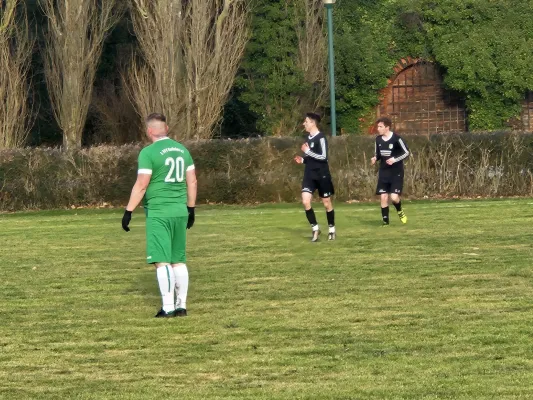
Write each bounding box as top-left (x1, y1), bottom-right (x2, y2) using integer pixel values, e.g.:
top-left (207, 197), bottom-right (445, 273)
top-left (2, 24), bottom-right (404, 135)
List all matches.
top-left (0, 145), bottom-right (140, 211)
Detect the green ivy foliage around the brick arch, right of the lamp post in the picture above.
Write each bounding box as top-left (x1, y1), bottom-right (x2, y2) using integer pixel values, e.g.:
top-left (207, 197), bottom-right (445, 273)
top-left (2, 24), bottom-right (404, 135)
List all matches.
top-left (335, 0), bottom-right (533, 131)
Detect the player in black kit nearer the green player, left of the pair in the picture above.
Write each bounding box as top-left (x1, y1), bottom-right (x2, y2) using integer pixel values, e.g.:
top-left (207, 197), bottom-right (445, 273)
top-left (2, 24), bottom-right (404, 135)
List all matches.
top-left (294, 113), bottom-right (336, 242)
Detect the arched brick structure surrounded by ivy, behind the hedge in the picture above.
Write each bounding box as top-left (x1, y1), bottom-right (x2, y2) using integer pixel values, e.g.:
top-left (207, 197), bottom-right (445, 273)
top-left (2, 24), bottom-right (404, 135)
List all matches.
top-left (377, 58), bottom-right (466, 135)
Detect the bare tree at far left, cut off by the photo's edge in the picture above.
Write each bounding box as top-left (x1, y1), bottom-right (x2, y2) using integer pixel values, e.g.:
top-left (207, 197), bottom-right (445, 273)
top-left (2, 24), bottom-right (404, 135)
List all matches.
top-left (0, 0), bottom-right (33, 149)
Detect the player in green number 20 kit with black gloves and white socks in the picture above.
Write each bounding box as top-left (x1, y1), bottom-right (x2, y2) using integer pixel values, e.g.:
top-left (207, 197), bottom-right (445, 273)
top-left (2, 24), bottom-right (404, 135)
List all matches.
top-left (122, 114), bottom-right (197, 318)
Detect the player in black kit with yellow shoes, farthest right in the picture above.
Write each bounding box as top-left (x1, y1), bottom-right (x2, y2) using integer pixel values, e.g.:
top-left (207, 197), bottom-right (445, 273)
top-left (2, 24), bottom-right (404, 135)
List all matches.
top-left (371, 117), bottom-right (409, 226)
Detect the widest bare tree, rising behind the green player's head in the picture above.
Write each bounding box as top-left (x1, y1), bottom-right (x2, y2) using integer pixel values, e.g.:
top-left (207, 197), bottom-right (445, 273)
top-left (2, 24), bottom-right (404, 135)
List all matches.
top-left (129, 0), bottom-right (250, 139)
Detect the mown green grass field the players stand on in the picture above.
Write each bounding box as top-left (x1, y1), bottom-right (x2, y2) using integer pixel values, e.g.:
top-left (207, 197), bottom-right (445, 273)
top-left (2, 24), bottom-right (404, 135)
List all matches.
top-left (0, 199), bottom-right (533, 399)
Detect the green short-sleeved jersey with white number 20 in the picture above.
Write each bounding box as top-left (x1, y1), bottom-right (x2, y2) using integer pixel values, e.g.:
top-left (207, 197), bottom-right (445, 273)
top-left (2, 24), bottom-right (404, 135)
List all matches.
top-left (138, 138), bottom-right (194, 217)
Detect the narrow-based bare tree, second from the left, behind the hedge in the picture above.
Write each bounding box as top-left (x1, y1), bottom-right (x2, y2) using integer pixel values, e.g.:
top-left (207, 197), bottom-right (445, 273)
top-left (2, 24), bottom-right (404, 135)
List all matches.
top-left (41, 0), bottom-right (123, 150)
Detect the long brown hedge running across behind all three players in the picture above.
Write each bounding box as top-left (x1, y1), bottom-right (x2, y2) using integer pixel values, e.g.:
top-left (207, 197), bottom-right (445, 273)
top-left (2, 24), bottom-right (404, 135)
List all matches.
top-left (0, 132), bottom-right (533, 211)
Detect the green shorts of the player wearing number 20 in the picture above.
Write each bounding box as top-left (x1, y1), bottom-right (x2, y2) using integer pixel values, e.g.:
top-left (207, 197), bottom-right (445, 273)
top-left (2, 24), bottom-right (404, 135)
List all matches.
top-left (146, 217), bottom-right (188, 264)
